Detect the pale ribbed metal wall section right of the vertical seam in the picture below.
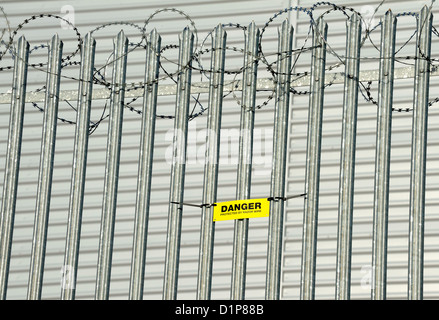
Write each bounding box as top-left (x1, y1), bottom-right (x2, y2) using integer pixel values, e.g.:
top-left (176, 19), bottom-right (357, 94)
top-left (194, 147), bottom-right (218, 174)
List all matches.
top-left (288, 1), bottom-right (439, 299)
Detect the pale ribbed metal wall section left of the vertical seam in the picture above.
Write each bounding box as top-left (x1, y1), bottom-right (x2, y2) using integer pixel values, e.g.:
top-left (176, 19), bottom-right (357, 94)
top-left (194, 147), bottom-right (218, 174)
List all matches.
top-left (0, 1), bottom-right (288, 299)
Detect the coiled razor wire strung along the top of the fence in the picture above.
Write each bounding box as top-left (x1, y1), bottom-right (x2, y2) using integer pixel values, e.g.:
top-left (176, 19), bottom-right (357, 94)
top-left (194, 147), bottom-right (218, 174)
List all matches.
top-left (0, 0), bottom-right (439, 133)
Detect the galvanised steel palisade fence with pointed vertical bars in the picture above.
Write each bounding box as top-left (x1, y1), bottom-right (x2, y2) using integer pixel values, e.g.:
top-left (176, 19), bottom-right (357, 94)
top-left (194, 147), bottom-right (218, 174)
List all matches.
top-left (0, 7), bottom-right (432, 299)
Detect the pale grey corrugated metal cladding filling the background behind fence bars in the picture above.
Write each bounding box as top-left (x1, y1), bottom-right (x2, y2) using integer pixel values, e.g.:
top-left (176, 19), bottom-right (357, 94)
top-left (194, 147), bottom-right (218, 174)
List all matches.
top-left (0, 0), bottom-right (439, 299)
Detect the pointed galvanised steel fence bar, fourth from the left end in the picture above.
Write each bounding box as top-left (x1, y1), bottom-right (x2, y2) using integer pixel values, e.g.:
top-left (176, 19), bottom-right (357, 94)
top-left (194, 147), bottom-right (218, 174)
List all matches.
top-left (95, 31), bottom-right (128, 300)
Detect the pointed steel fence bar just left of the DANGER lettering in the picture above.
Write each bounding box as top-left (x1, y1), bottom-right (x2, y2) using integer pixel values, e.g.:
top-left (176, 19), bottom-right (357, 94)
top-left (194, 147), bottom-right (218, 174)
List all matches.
top-left (197, 24), bottom-right (227, 300)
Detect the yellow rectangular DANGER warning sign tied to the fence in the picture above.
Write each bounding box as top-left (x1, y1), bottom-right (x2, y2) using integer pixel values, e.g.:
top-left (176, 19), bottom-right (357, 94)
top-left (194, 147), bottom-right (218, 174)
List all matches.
top-left (213, 198), bottom-right (270, 221)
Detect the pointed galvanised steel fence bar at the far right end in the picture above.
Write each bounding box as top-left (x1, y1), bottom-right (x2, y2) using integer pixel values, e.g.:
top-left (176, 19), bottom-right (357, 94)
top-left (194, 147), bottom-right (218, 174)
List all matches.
top-left (408, 6), bottom-right (433, 300)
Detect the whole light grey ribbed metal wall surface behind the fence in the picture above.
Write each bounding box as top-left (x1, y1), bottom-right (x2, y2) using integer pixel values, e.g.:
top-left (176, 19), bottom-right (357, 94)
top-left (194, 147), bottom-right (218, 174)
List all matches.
top-left (0, 0), bottom-right (439, 299)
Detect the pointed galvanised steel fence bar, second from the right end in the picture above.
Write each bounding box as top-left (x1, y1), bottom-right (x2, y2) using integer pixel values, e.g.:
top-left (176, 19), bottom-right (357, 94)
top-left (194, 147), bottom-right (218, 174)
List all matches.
top-left (371, 10), bottom-right (397, 300)
